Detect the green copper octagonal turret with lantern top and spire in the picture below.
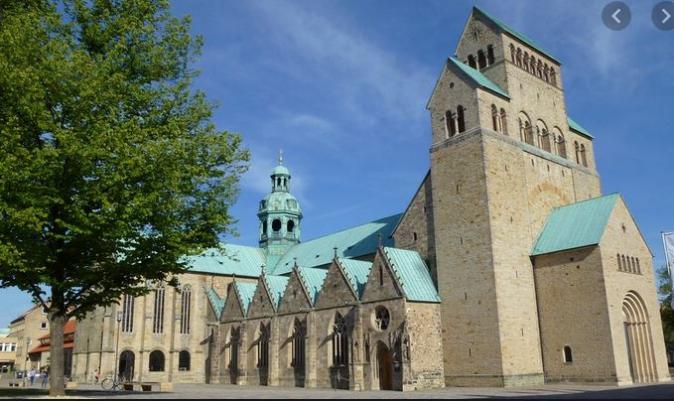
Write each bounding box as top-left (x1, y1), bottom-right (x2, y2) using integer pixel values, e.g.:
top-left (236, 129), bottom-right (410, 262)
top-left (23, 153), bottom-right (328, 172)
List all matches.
top-left (257, 152), bottom-right (302, 259)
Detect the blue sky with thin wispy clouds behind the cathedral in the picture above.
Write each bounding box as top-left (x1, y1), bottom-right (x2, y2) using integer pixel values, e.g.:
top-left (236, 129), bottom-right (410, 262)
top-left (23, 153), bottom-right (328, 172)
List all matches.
top-left (0, 0), bottom-right (674, 327)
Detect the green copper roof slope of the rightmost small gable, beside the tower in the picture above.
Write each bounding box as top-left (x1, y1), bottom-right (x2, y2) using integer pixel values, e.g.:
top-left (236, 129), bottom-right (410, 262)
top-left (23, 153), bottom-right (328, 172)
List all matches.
top-left (384, 248), bottom-right (440, 302)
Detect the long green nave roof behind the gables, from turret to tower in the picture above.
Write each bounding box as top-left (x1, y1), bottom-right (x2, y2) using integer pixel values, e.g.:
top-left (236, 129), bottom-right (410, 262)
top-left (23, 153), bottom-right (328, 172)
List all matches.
top-left (273, 214), bottom-right (402, 275)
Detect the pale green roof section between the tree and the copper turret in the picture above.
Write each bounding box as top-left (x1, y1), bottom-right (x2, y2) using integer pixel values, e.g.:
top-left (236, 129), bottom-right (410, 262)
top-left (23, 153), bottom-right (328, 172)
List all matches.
top-left (186, 244), bottom-right (265, 277)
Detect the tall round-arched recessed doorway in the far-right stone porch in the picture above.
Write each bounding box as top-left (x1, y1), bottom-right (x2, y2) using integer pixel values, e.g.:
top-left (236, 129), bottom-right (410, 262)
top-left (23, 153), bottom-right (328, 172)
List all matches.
top-left (622, 291), bottom-right (657, 383)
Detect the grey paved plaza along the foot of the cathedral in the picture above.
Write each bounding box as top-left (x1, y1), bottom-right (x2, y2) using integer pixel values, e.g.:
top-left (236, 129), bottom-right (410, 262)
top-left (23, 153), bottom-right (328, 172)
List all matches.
top-left (0, 382), bottom-right (674, 399)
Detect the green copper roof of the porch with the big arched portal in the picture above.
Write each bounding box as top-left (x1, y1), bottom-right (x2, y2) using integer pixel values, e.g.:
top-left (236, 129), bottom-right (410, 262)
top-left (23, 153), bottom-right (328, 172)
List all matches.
top-left (531, 194), bottom-right (620, 256)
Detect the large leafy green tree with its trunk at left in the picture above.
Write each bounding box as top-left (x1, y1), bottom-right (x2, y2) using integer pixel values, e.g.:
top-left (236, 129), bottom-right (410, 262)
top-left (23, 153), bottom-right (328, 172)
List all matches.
top-left (0, 0), bottom-right (249, 395)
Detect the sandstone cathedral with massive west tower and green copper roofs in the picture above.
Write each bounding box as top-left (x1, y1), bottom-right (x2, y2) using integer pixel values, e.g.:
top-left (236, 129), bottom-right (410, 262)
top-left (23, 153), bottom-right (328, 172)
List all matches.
top-left (73, 7), bottom-right (669, 391)
